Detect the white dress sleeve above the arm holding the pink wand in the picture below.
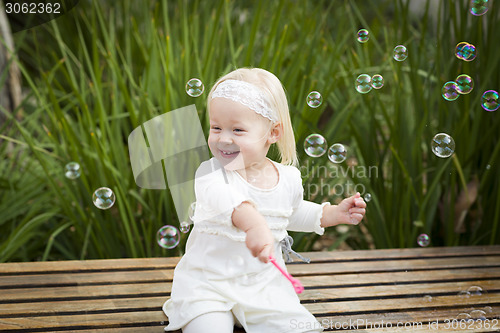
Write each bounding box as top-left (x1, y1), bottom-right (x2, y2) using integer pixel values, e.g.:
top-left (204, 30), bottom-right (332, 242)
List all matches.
top-left (193, 159), bottom-right (255, 225)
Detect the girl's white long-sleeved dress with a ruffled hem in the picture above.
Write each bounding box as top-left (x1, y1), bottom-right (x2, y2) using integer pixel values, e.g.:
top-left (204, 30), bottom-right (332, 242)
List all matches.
top-left (163, 158), bottom-right (328, 333)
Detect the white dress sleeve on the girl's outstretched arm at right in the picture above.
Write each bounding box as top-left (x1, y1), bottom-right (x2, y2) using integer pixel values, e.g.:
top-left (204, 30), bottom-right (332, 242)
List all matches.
top-left (287, 165), bottom-right (330, 235)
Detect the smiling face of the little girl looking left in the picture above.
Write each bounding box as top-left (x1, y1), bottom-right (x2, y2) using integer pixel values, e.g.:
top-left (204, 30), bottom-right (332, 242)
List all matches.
top-left (208, 98), bottom-right (279, 171)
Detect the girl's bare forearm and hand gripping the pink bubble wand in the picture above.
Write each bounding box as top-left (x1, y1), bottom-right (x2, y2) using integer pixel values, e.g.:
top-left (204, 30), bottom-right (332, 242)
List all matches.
top-left (232, 201), bottom-right (274, 263)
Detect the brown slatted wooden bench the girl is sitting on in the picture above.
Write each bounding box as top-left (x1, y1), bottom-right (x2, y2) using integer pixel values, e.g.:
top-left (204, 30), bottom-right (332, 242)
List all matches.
top-left (0, 246), bottom-right (500, 333)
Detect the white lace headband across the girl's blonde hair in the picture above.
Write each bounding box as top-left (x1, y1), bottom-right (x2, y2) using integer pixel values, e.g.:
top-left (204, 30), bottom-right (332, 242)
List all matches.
top-left (212, 80), bottom-right (278, 122)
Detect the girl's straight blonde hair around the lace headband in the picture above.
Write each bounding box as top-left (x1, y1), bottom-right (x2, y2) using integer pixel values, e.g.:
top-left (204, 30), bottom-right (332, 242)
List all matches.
top-left (207, 68), bottom-right (298, 166)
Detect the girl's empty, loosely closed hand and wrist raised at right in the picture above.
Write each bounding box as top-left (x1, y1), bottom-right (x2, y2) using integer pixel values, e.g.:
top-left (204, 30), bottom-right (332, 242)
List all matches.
top-left (321, 192), bottom-right (366, 227)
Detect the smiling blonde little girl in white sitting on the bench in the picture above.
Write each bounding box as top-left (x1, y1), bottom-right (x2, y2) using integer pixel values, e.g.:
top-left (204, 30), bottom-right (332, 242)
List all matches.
top-left (163, 68), bottom-right (366, 333)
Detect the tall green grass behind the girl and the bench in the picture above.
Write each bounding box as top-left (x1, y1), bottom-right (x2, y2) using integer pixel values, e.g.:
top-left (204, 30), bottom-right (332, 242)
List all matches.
top-left (0, 0), bottom-right (500, 261)
